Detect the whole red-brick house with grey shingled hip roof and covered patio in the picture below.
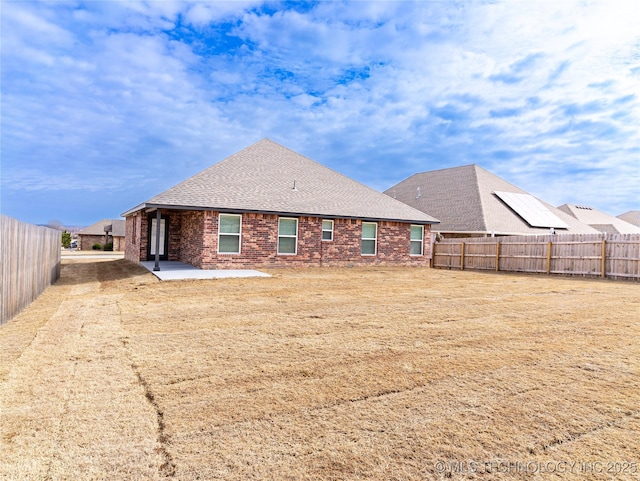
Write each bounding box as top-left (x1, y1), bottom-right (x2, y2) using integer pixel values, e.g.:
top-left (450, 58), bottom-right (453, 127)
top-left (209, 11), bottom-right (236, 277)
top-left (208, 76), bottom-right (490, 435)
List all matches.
top-left (122, 139), bottom-right (438, 269)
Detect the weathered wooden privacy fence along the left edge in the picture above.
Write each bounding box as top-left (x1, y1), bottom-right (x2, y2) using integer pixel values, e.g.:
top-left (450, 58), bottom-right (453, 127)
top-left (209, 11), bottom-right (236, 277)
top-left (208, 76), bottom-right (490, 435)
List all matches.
top-left (0, 214), bottom-right (61, 325)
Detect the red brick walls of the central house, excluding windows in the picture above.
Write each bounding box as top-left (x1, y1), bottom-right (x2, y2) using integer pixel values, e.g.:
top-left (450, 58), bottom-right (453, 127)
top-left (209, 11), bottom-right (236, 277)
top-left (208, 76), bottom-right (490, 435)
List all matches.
top-left (125, 210), bottom-right (431, 269)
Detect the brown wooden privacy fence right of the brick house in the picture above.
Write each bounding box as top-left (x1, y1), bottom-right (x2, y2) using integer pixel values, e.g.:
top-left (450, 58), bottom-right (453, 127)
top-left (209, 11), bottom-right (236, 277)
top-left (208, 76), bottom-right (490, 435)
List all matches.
top-left (432, 234), bottom-right (640, 281)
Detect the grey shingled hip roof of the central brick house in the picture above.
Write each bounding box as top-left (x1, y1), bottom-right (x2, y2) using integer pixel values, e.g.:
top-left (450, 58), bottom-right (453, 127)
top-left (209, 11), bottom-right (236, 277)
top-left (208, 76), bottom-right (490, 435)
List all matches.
top-left (122, 139), bottom-right (438, 224)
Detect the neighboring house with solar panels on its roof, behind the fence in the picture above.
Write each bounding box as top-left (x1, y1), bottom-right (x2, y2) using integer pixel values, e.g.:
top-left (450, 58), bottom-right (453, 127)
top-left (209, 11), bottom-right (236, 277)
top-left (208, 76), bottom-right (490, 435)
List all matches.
top-left (385, 164), bottom-right (598, 237)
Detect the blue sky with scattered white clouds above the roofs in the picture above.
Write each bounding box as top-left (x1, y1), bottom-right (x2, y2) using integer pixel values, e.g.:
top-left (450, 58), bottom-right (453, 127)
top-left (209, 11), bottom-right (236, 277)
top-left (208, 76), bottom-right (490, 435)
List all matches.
top-left (0, 0), bottom-right (640, 225)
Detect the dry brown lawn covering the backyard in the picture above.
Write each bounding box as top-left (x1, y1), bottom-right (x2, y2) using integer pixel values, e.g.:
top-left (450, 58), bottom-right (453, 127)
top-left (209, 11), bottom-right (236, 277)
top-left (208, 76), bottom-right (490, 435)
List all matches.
top-left (0, 259), bottom-right (640, 480)
